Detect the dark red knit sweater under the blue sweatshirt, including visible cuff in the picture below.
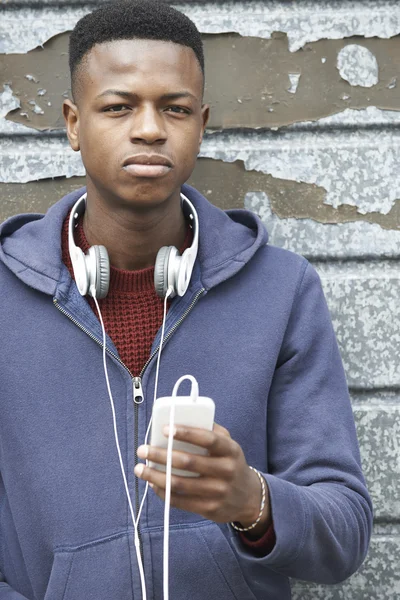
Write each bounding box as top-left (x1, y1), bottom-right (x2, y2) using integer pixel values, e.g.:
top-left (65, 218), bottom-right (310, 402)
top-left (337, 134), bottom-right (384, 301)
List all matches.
top-left (62, 215), bottom-right (275, 556)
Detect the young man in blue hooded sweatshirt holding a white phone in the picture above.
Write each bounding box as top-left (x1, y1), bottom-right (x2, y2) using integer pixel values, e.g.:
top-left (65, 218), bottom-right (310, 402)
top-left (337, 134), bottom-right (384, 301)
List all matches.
top-left (0, 1), bottom-right (372, 600)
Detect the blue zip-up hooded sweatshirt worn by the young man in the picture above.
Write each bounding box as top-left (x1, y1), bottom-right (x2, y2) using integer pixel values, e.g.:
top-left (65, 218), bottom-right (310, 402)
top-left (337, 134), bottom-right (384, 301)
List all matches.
top-left (0, 186), bottom-right (372, 600)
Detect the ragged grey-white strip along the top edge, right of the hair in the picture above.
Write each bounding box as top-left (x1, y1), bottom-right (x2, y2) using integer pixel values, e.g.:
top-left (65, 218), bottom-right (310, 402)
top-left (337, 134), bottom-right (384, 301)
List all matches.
top-left (184, 0), bottom-right (400, 52)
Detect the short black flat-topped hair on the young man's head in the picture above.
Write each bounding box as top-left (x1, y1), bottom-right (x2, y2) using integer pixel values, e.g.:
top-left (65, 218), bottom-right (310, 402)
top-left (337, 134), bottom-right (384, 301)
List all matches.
top-left (69, 0), bottom-right (204, 98)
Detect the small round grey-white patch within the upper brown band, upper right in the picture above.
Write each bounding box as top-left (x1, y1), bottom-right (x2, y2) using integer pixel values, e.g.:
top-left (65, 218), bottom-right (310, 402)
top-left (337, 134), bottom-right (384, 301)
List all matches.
top-left (337, 44), bottom-right (378, 86)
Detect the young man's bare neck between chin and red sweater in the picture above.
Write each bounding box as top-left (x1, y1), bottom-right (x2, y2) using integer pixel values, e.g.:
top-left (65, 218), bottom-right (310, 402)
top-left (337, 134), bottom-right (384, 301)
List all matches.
top-left (83, 187), bottom-right (187, 271)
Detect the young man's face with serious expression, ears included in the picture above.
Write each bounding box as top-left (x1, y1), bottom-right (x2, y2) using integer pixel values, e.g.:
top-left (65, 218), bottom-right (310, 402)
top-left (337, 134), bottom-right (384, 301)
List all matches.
top-left (63, 40), bottom-right (209, 208)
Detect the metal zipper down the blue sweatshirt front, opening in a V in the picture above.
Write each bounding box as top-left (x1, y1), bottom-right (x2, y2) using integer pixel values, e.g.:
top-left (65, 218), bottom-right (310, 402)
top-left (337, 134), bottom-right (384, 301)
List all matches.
top-left (53, 288), bottom-right (205, 580)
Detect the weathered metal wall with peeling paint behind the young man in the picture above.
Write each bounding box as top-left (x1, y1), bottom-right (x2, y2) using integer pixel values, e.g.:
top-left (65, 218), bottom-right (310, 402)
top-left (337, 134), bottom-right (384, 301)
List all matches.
top-left (0, 0), bottom-right (400, 600)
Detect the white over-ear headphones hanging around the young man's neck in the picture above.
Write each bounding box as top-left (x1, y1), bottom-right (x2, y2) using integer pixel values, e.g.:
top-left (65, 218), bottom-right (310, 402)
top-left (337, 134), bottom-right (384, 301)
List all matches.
top-left (68, 193), bottom-right (199, 299)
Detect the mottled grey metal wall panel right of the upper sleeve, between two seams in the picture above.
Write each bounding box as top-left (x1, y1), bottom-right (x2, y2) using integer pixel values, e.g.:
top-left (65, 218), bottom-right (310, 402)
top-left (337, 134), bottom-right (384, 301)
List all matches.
top-left (315, 261), bottom-right (400, 390)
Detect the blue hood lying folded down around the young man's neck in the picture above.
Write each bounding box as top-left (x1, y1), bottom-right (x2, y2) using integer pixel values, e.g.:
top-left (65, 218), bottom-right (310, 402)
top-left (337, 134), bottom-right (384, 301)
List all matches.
top-left (0, 185), bottom-right (268, 296)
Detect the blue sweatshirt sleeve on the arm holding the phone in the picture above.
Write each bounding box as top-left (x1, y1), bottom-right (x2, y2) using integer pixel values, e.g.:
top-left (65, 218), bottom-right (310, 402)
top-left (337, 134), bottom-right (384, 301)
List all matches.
top-left (230, 263), bottom-right (372, 583)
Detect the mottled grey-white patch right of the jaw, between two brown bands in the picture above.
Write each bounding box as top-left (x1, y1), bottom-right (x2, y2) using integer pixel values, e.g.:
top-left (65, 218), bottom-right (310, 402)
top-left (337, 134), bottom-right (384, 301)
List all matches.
top-left (201, 128), bottom-right (400, 215)
